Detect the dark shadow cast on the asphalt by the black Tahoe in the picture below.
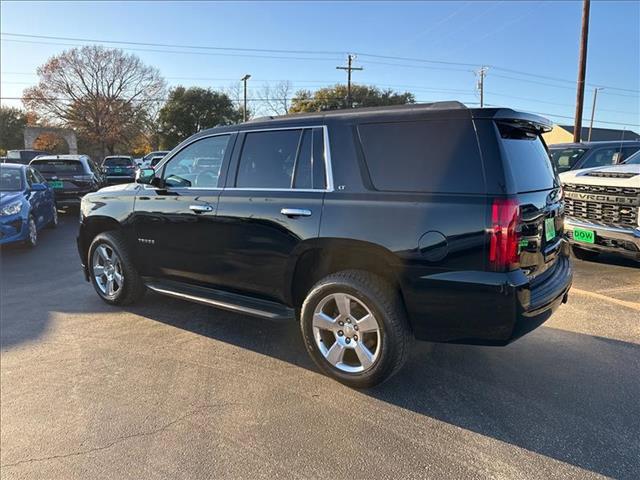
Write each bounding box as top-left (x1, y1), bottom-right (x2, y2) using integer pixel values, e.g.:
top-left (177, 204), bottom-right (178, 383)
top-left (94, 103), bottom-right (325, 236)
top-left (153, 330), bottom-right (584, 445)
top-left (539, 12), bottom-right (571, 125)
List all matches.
top-left (125, 294), bottom-right (640, 478)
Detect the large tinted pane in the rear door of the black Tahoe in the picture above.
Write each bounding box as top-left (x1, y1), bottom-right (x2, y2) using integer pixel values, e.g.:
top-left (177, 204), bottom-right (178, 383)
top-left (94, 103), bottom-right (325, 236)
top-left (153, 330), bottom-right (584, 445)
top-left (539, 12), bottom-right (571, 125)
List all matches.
top-left (236, 130), bottom-right (302, 188)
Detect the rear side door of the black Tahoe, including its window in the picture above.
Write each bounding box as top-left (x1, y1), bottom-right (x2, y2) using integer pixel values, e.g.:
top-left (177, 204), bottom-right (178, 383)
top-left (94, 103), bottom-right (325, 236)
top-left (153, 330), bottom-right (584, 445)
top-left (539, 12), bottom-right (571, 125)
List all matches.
top-left (213, 127), bottom-right (331, 301)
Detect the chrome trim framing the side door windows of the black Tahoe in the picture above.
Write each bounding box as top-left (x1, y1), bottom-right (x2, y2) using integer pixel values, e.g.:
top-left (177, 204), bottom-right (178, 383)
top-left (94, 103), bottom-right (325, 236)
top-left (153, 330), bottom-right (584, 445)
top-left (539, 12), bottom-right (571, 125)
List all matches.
top-left (150, 125), bottom-right (334, 193)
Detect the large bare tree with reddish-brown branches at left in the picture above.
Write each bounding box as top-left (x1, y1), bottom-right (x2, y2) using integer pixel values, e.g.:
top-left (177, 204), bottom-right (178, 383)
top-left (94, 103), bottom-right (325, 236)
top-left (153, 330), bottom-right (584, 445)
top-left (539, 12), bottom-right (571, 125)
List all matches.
top-left (23, 46), bottom-right (166, 155)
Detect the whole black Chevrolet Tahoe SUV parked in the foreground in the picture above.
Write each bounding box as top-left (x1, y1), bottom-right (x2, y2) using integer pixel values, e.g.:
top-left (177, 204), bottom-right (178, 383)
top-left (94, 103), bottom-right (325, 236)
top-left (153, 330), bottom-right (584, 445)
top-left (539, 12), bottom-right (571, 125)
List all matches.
top-left (78, 102), bottom-right (572, 387)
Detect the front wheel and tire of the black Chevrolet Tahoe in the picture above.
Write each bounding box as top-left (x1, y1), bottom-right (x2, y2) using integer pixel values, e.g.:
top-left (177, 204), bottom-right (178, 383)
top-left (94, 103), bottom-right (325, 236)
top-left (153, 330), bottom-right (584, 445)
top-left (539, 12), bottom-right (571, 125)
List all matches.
top-left (87, 231), bottom-right (146, 305)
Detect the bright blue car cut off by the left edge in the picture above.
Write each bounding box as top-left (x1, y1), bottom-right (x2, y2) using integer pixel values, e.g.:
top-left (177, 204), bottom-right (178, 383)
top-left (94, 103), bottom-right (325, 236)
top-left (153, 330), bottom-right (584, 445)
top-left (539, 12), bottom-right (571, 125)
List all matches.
top-left (0, 163), bottom-right (58, 247)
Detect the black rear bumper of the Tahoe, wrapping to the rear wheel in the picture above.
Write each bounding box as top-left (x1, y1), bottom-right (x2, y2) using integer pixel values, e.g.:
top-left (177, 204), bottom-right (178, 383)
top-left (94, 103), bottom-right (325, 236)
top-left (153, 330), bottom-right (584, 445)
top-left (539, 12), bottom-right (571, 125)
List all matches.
top-left (403, 242), bottom-right (573, 345)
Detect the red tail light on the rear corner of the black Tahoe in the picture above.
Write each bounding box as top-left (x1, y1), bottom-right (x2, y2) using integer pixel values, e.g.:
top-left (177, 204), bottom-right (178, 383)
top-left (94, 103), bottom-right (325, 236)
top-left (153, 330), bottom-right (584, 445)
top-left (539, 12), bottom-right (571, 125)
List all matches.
top-left (489, 198), bottom-right (520, 272)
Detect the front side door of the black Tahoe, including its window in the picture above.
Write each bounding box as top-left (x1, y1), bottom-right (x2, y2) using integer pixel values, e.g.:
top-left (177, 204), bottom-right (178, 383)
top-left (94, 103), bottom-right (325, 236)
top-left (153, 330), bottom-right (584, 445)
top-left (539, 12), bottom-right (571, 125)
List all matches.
top-left (133, 133), bottom-right (235, 284)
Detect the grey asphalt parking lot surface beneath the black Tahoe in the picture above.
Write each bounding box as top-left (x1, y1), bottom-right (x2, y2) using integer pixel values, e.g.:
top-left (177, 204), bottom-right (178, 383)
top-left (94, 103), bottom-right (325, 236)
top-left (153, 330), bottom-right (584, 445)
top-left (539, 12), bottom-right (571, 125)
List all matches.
top-left (0, 212), bottom-right (640, 479)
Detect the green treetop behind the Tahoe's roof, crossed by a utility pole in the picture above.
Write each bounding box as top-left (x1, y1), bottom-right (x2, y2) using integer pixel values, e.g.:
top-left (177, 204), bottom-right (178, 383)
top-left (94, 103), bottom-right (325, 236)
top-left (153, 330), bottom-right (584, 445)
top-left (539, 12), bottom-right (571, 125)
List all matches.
top-left (289, 85), bottom-right (415, 113)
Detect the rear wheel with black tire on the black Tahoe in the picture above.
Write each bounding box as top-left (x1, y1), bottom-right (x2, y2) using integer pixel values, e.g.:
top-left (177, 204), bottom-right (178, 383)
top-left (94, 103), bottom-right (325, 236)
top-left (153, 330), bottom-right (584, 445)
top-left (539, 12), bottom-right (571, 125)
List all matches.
top-left (301, 270), bottom-right (410, 388)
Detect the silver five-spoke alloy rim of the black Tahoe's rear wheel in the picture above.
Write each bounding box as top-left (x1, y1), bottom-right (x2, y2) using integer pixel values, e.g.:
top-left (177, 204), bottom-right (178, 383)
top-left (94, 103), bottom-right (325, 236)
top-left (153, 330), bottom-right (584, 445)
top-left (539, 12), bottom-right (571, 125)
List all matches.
top-left (312, 293), bottom-right (382, 373)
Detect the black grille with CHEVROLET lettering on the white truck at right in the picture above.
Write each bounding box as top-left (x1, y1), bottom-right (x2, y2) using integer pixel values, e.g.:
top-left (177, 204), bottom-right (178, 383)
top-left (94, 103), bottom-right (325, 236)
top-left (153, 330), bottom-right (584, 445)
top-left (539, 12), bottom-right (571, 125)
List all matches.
top-left (564, 184), bottom-right (640, 228)
